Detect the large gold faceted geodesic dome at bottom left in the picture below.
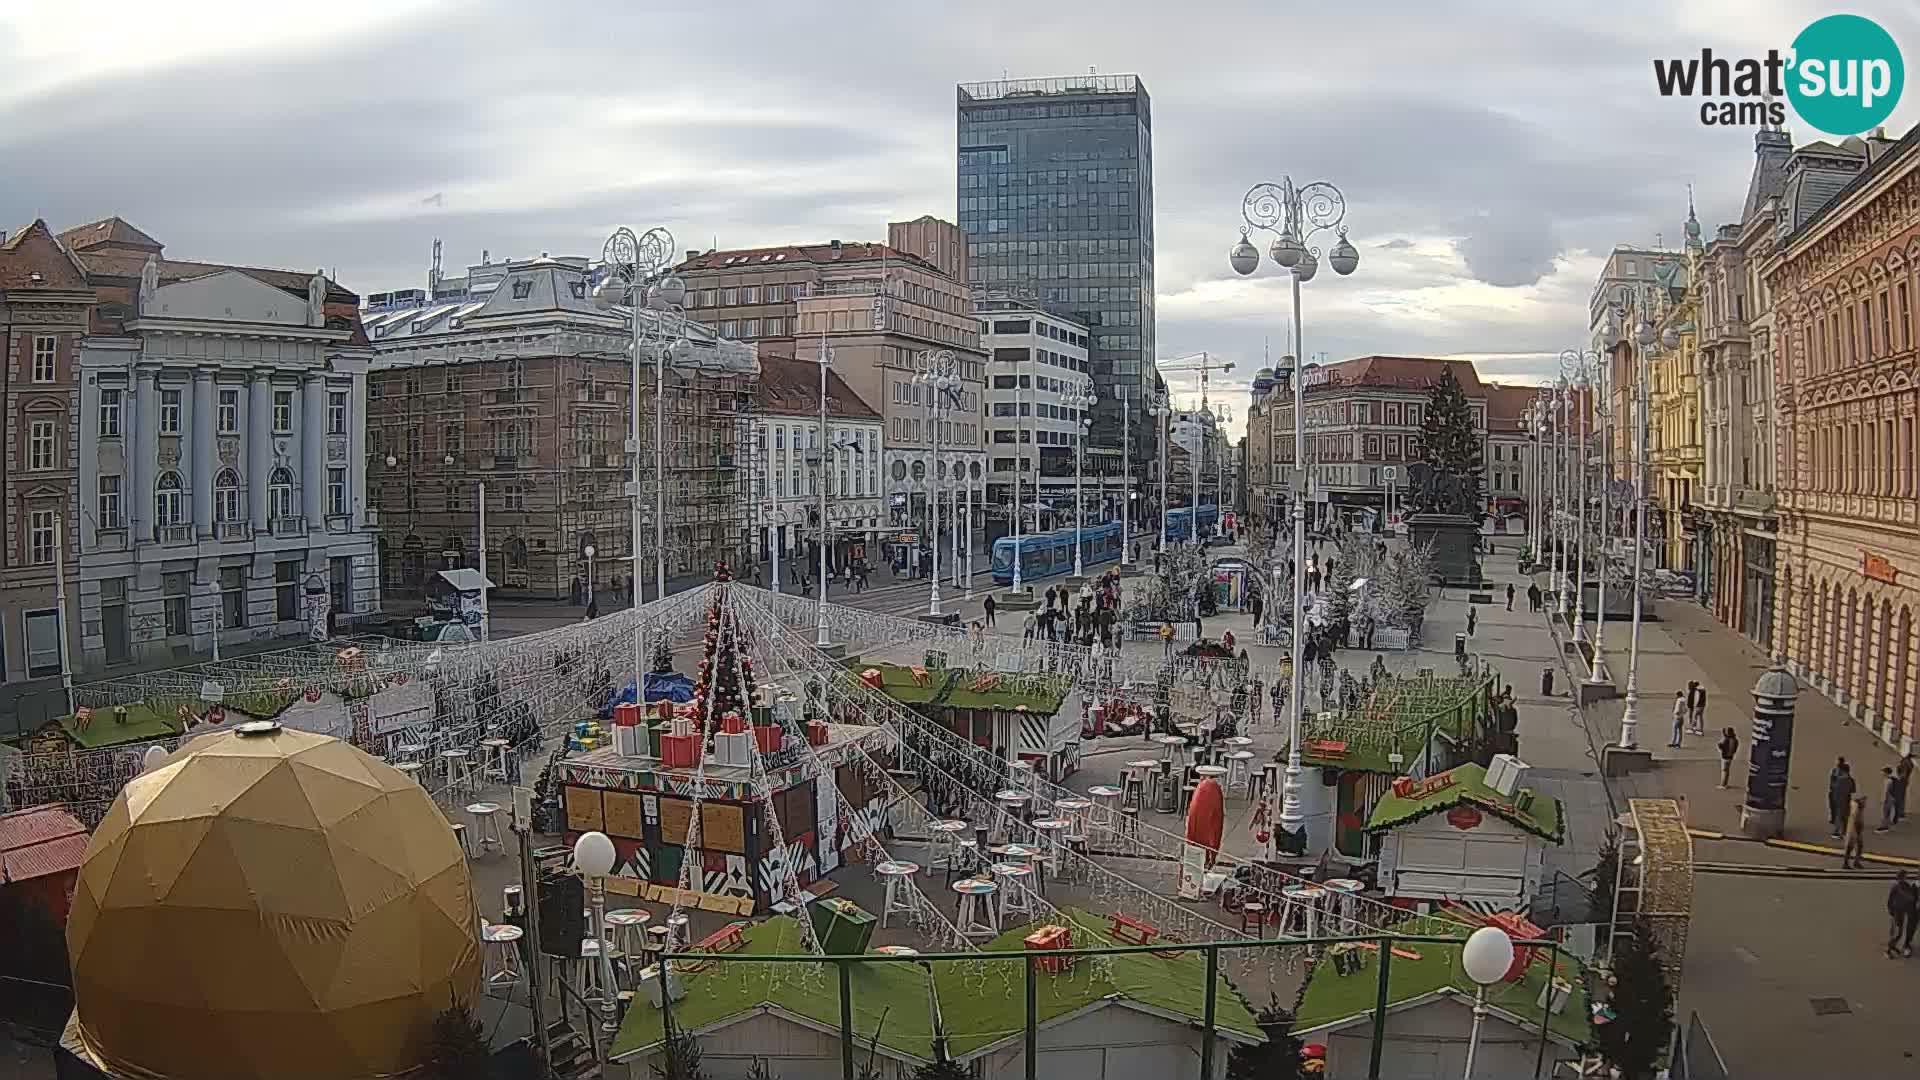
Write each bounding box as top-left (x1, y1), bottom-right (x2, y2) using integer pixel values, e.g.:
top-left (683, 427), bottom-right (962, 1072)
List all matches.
top-left (67, 724), bottom-right (480, 1080)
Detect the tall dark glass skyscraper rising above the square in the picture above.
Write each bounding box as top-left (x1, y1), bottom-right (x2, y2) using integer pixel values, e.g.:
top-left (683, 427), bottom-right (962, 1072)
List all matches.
top-left (958, 75), bottom-right (1158, 470)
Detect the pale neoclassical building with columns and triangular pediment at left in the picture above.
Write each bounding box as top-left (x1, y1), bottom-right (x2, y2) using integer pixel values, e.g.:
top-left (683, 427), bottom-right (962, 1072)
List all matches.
top-left (61, 217), bottom-right (380, 671)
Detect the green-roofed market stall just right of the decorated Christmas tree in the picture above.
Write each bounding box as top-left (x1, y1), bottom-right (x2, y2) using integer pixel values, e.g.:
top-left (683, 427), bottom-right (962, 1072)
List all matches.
top-left (860, 663), bottom-right (1081, 782)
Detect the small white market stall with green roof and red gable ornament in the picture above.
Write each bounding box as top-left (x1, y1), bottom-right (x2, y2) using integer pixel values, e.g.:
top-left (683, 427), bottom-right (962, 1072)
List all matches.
top-left (1367, 753), bottom-right (1567, 911)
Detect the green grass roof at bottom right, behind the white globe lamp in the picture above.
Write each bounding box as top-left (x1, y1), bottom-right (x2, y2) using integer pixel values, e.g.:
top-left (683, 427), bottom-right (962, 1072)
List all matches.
top-left (1294, 942), bottom-right (1592, 1043)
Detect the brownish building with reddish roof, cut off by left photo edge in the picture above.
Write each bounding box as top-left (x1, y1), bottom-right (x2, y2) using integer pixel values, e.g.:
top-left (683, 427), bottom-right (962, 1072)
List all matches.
top-left (0, 221), bottom-right (94, 738)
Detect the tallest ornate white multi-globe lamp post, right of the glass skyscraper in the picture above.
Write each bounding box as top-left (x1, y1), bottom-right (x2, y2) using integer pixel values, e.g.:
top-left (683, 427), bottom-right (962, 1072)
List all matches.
top-left (1227, 177), bottom-right (1359, 851)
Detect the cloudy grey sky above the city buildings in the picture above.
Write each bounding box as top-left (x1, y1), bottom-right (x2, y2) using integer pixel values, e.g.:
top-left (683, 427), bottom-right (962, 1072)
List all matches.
top-left (0, 0), bottom-right (1920, 438)
